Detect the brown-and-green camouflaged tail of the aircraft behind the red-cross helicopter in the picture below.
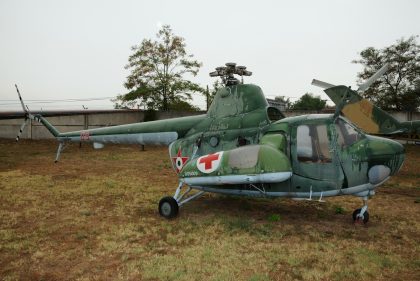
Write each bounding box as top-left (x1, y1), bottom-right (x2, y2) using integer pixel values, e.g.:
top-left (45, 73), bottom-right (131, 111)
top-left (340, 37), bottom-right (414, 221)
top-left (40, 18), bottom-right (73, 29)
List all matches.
top-left (312, 64), bottom-right (420, 143)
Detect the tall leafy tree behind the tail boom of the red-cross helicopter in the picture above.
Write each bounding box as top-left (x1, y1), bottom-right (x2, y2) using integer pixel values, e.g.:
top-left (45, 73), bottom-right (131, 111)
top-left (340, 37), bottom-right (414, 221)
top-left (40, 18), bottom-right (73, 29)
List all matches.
top-left (114, 25), bottom-right (202, 110)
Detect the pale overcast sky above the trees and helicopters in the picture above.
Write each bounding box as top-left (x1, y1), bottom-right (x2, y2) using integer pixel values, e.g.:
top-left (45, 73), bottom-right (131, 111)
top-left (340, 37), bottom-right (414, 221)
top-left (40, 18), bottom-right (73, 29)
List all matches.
top-left (0, 0), bottom-right (420, 111)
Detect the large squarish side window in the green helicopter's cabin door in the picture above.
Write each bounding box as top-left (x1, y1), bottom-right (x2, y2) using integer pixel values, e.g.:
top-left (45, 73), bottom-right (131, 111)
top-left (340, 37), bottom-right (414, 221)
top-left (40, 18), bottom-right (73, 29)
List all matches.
top-left (296, 124), bottom-right (331, 163)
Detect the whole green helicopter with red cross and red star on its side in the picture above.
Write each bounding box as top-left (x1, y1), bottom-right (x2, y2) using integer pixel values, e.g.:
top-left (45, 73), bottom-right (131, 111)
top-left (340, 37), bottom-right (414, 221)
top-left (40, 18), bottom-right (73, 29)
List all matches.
top-left (16, 63), bottom-right (405, 223)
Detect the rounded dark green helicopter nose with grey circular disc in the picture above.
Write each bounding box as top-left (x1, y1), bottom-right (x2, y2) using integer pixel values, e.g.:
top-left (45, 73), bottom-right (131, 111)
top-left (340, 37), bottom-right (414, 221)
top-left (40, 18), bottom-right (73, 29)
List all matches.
top-left (366, 136), bottom-right (405, 185)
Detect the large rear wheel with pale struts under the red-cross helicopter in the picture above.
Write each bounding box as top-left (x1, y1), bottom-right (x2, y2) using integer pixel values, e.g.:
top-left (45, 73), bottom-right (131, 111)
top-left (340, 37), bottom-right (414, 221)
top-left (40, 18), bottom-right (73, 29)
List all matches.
top-left (159, 182), bottom-right (204, 219)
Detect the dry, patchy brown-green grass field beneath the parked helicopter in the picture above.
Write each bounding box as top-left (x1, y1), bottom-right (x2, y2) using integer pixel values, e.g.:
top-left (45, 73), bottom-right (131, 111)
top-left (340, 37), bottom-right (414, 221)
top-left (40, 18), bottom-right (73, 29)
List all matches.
top-left (0, 140), bottom-right (420, 281)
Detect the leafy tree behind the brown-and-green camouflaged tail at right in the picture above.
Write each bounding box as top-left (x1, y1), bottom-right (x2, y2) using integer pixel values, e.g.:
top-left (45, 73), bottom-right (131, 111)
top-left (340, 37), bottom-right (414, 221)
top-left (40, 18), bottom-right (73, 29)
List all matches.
top-left (353, 36), bottom-right (420, 110)
